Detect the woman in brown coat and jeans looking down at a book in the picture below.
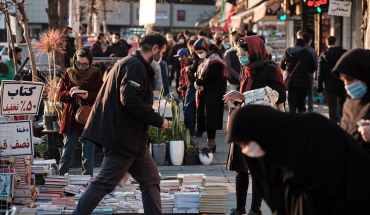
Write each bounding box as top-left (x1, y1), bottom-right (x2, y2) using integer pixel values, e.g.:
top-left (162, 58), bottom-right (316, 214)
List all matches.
top-left (57, 48), bottom-right (103, 176)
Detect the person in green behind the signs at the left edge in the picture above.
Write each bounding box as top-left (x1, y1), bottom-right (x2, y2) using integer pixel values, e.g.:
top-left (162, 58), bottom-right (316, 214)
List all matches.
top-left (0, 47), bottom-right (22, 86)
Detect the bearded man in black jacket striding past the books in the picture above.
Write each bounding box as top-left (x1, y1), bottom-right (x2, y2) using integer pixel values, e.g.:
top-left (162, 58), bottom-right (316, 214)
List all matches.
top-left (73, 32), bottom-right (168, 215)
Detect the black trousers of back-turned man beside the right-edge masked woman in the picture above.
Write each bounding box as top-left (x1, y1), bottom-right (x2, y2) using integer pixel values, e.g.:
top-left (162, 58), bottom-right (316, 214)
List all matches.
top-left (326, 88), bottom-right (347, 122)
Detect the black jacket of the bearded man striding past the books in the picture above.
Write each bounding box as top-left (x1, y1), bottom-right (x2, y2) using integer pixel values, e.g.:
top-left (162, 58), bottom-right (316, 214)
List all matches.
top-left (82, 50), bottom-right (163, 159)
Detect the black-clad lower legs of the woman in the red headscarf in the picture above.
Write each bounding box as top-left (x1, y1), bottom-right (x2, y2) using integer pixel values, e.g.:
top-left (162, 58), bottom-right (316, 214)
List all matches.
top-left (235, 172), bottom-right (262, 214)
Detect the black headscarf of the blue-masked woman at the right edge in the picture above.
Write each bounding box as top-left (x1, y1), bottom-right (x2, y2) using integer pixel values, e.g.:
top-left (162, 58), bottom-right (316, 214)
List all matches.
top-left (332, 49), bottom-right (370, 153)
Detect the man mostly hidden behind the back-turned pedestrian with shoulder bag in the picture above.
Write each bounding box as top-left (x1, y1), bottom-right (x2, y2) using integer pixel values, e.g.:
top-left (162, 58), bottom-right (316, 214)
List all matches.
top-left (302, 32), bottom-right (318, 112)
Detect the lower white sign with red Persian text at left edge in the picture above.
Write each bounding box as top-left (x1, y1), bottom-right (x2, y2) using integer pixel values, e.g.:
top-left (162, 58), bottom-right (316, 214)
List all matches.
top-left (0, 120), bottom-right (33, 157)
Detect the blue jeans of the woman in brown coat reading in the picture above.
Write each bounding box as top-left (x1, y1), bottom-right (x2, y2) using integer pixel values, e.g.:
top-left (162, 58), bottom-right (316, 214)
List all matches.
top-left (59, 129), bottom-right (95, 176)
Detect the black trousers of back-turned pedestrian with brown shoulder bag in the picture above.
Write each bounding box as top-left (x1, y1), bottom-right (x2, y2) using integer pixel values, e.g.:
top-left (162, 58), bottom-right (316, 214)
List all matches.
top-left (288, 87), bottom-right (307, 113)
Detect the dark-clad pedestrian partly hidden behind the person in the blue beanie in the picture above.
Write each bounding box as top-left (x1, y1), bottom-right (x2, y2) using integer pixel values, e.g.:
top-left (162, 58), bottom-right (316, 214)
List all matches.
top-left (169, 33), bottom-right (186, 96)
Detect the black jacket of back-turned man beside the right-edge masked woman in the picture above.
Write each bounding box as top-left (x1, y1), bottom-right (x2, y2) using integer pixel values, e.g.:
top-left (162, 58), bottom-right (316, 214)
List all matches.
top-left (317, 46), bottom-right (347, 93)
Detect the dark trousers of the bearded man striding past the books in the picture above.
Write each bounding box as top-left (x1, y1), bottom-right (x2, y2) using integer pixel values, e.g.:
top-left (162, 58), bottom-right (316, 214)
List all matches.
top-left (73, 147), bottom-right (162, 215)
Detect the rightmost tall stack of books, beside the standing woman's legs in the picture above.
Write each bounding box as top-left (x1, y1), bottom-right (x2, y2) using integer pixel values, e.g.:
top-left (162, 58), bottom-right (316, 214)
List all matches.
top-left (199, 185), bottom-right (229, 214)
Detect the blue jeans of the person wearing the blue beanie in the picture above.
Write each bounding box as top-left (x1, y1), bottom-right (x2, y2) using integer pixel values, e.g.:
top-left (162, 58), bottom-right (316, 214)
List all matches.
top-left (184, 88), bottom-right (196, 135)
